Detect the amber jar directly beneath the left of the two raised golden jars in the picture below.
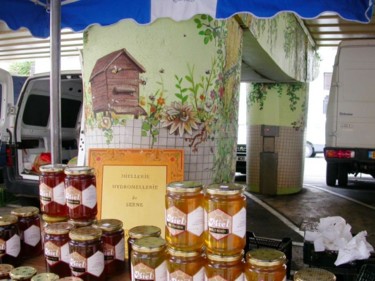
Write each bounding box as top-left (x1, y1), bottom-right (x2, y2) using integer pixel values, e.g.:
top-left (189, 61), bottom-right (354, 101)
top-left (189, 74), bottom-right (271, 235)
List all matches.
top-left (167, 248), bottom-right (205, 281)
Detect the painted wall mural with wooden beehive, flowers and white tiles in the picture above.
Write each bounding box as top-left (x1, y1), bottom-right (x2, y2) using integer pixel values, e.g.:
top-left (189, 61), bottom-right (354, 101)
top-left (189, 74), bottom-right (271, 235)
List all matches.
top-left (84, 15), bottom-right (242, 183)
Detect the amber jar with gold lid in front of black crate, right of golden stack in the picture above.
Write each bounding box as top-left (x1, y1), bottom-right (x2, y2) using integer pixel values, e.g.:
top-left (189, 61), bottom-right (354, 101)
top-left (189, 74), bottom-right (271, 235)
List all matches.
top-left (245, 248), bottom-right (286, 281)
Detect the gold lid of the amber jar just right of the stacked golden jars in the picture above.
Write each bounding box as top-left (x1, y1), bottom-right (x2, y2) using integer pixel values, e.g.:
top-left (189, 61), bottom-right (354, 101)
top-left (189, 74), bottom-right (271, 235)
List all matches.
top-left (246, 248), bottom-right (286, 266)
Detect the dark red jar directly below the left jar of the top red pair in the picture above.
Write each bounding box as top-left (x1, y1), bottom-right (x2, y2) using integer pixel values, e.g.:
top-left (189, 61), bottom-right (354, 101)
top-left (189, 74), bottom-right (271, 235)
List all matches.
top-left (44, 222), bottom-right (73, 277)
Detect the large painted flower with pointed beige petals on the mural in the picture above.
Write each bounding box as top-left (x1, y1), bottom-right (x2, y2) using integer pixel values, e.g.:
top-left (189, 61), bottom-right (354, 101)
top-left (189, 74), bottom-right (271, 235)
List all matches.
top-left (162, 102), bottom-right (200, 137)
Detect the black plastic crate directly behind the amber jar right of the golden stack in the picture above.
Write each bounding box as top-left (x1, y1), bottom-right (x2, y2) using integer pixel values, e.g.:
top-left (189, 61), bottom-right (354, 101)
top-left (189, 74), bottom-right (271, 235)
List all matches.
top-left (245, 231), bottom-right (292, 279)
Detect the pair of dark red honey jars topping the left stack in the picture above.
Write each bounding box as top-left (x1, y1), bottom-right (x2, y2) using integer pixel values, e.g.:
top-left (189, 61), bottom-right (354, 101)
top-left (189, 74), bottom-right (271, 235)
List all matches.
top-left (39, 164), bottom-right (97, 220)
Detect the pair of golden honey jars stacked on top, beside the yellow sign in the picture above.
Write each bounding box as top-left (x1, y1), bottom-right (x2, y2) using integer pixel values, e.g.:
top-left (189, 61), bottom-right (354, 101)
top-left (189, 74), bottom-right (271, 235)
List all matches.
top-left (165, 181), bottom-right (246, 255)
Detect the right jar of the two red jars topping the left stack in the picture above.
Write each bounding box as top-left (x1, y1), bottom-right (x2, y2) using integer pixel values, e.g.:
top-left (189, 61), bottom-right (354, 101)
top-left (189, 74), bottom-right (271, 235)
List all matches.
top-left (65, 166), bottom-right (98, 220)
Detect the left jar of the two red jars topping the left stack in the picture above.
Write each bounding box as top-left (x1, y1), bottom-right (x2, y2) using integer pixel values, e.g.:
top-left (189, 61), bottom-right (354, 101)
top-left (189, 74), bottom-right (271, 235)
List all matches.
top-left (39, 164), bottom-right (68, 217)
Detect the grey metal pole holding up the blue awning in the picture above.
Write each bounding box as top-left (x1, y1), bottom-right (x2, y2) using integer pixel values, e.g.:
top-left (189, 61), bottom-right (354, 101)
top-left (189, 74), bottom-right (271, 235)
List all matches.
top-left (50, 0), bottom-right (62, 164)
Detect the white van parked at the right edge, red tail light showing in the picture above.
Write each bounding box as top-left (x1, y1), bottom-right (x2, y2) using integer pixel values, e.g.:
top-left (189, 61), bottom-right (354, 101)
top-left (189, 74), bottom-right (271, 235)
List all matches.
top-left (324, 40), bottom-right (375, 186)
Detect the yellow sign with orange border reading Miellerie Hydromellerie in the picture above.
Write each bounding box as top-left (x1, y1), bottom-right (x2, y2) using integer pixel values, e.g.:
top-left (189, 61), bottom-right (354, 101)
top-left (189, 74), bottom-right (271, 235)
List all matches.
top-left (89, 149), bottom-right (184, 237)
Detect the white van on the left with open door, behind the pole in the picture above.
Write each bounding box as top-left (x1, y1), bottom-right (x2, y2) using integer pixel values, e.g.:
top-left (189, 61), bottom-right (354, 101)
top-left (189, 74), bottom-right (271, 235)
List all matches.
top-left (0, 69), bottom-right (83, 202)
